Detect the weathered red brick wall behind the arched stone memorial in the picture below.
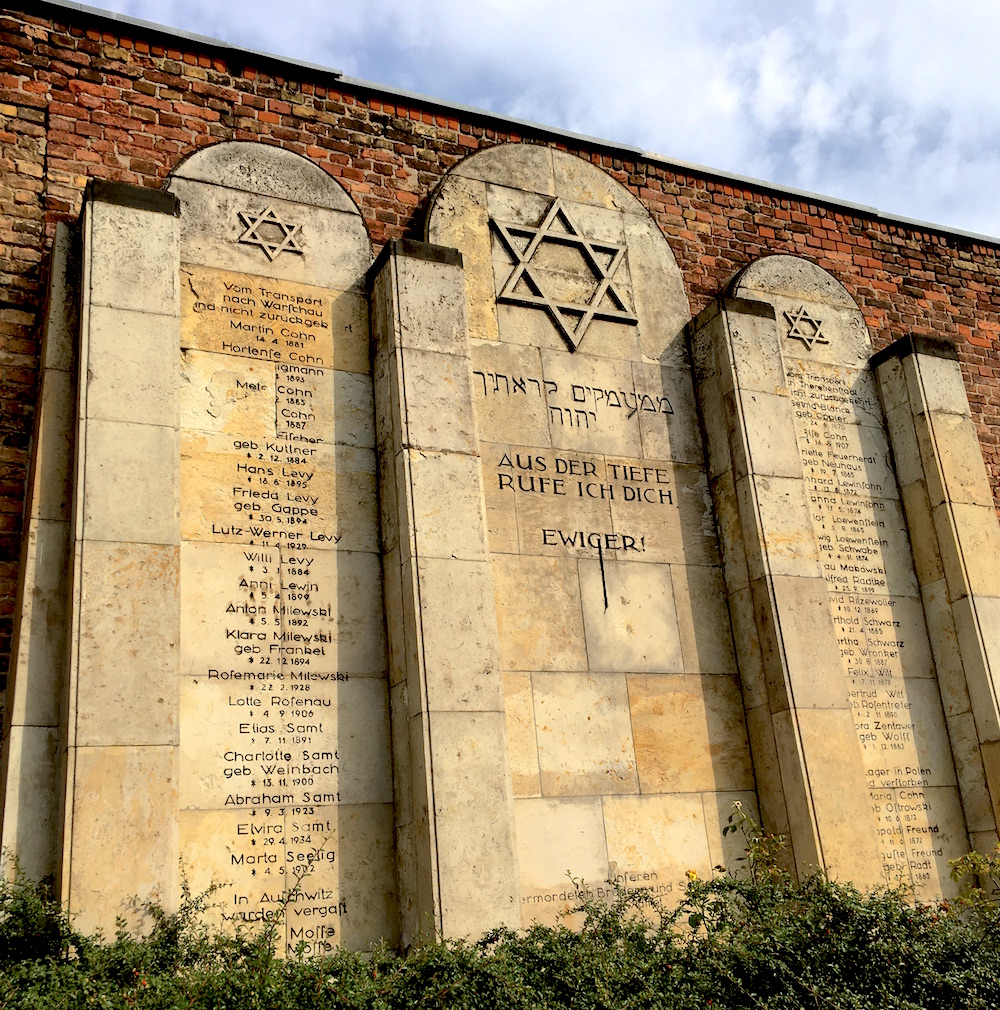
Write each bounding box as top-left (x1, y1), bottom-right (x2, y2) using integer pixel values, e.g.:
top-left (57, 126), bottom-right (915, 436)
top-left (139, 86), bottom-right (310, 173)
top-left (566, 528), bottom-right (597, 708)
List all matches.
top-left (0, 4), bottom-right (1000, 690)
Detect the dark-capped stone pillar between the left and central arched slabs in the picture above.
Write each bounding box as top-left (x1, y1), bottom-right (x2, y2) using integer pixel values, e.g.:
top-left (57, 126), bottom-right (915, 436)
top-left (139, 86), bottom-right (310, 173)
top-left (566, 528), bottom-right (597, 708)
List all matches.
top-left (371, 241), bottom-right (519, 943)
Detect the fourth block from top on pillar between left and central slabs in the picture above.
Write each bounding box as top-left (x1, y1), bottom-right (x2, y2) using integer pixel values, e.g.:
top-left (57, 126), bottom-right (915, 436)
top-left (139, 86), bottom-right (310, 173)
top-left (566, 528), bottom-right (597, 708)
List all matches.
top-left (410, 558), bottom-right (503, 712)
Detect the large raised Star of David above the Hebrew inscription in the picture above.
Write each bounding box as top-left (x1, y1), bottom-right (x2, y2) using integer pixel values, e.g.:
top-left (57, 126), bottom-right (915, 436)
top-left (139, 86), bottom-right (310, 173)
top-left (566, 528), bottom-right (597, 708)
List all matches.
top-left (490, 197), bottom-right (637, 350)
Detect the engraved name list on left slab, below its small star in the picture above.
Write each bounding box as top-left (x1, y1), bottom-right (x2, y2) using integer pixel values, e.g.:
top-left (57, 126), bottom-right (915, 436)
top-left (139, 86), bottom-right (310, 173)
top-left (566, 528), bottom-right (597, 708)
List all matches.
top-left (181, 264), bottom-right (391, 952)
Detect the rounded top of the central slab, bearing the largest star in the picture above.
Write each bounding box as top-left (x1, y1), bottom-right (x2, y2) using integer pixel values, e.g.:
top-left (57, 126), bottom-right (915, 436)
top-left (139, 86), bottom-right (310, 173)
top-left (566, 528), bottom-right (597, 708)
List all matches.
top-left (425, 143), bottom-right (690, 365)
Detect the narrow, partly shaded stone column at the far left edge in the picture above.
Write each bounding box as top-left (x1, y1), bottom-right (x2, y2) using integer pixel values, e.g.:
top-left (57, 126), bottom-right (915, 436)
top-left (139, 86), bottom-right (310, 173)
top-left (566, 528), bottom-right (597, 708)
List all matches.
top-left (0, 224), bottom-right (80, 880)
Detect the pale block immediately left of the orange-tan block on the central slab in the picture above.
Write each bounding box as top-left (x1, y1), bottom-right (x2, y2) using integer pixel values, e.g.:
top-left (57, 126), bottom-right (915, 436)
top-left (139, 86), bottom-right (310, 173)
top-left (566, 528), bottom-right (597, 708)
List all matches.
top-left (531, 674), bottom-right (639, 796)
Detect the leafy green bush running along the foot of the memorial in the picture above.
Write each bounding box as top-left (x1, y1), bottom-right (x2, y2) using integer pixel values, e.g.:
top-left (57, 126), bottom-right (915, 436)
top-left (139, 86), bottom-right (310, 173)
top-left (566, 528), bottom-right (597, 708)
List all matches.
top-left (0, 810), bottom-right (1000, 1010)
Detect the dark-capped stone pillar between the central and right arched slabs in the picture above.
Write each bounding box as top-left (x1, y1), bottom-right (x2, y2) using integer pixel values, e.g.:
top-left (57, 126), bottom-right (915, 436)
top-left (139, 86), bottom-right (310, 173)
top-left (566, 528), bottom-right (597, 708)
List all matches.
top-left (692, 298), bottom-right (882, 885)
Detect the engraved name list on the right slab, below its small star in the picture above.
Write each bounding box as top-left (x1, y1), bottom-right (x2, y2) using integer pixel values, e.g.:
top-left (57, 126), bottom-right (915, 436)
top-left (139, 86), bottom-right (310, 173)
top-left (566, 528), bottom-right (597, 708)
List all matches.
top-left (787, 359), bottom-right (964, 897)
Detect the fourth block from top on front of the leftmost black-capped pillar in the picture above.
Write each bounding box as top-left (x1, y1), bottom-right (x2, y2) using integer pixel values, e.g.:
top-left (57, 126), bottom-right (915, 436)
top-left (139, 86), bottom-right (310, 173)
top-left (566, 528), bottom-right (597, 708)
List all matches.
top-left (75, 540), bottom-right (180, 746)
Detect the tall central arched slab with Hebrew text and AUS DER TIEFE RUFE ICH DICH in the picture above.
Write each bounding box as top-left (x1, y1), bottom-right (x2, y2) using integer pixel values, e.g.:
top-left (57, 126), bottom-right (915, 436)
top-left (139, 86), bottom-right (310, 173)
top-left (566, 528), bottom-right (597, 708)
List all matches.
top-left (426, 146), bottom-right (754, 924)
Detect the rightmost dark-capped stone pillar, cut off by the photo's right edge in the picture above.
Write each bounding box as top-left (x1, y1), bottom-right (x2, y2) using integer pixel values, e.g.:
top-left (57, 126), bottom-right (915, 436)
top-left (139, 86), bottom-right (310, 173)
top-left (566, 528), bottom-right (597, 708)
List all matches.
top-left (872, 335), bottom-right (1000, 851)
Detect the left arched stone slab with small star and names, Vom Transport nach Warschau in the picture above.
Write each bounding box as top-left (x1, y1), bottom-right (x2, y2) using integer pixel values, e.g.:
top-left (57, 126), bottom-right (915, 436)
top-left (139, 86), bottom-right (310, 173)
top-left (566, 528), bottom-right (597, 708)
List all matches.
top-left (171, 143), bottom-right (397, 952)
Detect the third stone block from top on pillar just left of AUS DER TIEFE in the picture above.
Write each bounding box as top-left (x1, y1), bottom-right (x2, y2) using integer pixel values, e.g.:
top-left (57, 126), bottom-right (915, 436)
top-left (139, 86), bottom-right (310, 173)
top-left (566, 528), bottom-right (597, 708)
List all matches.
top-left (406, 450), bottom-right (486, 561)
